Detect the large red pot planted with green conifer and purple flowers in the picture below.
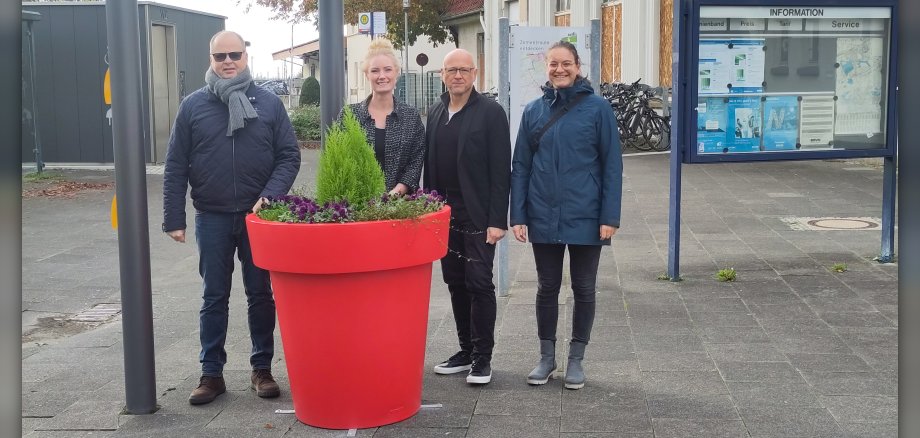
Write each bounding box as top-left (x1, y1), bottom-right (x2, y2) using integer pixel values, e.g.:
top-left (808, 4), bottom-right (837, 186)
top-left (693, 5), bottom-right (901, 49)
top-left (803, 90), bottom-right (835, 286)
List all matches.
top-left (246, 111), bottom-right (450, 429)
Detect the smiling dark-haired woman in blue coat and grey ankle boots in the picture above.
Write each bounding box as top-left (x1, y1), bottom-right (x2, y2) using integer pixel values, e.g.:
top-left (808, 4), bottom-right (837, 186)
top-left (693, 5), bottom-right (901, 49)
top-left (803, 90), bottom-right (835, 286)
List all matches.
top-left (511, 41), bottom-right (623, 389)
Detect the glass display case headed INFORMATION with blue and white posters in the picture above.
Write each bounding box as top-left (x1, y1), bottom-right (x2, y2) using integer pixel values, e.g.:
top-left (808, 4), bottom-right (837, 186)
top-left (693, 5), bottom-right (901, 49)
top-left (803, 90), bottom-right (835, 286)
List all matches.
top-left (684, 2), bottom-right (893, 162)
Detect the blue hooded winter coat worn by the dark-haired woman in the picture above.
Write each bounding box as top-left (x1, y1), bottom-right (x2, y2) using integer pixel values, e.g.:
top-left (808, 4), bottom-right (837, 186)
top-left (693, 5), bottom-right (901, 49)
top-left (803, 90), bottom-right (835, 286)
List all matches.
top-left (511, 79), bottom-right (623, 245)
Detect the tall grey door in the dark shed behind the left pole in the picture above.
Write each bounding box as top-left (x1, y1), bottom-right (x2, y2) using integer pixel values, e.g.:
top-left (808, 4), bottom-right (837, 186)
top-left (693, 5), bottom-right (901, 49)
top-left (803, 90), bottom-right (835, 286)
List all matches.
top-left (150, 24), bottom-right (179, 163)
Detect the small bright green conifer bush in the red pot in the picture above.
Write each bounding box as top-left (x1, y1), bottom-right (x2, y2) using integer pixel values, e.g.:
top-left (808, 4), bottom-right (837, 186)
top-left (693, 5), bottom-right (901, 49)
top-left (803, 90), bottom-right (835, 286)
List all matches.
top-left (316, 106), bottom-right (386, 208)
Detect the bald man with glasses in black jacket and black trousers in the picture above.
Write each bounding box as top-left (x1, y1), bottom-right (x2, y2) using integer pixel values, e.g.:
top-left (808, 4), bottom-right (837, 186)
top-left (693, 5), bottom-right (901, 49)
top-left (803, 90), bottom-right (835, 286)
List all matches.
top-left (424, 49), bottom-right (511, 385)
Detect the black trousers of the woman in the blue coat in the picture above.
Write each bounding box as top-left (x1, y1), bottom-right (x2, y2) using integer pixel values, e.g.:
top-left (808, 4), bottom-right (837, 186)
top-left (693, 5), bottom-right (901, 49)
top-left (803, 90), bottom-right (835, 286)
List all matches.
top-left (533, 243), bottom-right (602, 344)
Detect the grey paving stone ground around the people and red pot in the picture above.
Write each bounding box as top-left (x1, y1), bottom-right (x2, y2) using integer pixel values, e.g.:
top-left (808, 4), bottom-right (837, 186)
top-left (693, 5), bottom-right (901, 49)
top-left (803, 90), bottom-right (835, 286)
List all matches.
top-left (22, 150), bottom-right (898, 438)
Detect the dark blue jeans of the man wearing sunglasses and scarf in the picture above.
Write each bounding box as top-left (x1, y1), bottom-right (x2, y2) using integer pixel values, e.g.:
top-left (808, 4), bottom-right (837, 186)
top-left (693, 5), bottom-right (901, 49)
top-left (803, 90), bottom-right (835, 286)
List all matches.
top-left (195, 211), bottom-right (275, 376)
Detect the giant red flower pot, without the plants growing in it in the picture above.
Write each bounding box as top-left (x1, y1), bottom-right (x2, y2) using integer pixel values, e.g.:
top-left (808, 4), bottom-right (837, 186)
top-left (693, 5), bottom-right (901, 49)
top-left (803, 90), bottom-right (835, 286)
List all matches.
top-left (246, 206), bottom-right (450, 429)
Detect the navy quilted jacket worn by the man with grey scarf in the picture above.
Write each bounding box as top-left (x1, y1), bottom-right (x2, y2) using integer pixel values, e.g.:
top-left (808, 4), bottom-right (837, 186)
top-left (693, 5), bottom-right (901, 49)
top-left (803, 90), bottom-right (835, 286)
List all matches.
top-left (163, 84), bottom-right (300, 231)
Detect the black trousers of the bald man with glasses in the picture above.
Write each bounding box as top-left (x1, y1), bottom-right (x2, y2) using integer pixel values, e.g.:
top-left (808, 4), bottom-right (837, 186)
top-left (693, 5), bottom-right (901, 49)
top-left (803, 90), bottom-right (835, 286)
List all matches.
top-left (441, 193), bottom-right (496, 361)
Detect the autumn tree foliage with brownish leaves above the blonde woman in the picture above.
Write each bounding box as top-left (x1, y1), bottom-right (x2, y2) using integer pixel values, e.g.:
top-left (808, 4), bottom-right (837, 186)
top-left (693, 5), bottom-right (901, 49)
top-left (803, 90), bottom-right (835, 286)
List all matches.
top-left (250, 0), bottom-right (451, 49)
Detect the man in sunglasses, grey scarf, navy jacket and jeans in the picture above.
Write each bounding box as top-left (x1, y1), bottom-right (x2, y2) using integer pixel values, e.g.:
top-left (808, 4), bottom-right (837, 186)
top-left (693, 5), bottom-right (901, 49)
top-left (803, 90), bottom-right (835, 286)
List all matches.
top-left (163, 31), bottom-right (300, 405)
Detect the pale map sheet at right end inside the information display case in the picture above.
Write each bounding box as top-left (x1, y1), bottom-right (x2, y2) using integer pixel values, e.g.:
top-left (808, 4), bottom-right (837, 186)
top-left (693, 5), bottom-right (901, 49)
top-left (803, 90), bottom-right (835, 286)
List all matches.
top-left (834, 37), bottom-right (884, 135)
